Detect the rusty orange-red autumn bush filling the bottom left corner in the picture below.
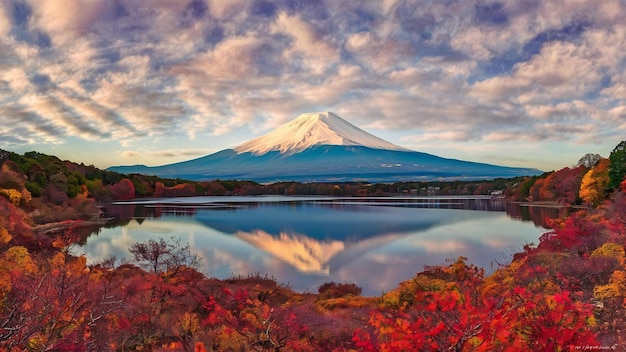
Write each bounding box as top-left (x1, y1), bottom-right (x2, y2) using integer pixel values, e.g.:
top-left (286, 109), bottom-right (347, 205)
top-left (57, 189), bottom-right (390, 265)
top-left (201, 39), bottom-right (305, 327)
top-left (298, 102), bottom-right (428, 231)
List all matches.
top-left (0, 226), bottom-right (121, 351)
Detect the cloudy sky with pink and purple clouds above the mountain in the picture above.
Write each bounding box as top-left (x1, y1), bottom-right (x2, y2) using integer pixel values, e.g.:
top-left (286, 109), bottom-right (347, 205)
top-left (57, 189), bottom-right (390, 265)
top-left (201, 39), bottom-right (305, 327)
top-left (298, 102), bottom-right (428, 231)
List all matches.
top-left (0, 0), bottom-right (626, 171)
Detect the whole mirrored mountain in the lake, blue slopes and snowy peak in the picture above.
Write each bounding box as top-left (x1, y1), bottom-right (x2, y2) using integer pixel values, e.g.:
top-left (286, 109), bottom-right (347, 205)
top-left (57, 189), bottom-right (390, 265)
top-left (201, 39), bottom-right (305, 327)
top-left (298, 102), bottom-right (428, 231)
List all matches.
top-left (195, 204), bottom-right (489, 275)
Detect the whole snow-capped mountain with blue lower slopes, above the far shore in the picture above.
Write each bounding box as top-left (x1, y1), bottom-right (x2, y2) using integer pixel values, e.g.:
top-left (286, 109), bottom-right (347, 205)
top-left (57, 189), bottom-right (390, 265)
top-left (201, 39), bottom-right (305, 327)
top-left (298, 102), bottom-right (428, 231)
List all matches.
top-left (108, 112), bottom-right (541, 183)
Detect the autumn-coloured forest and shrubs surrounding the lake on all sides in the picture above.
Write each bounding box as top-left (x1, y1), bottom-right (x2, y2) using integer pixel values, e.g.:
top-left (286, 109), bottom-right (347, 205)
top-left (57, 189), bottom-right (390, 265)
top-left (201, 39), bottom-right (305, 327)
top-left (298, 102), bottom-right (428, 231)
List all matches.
top-left (0, 141), bottom-right (626, 351)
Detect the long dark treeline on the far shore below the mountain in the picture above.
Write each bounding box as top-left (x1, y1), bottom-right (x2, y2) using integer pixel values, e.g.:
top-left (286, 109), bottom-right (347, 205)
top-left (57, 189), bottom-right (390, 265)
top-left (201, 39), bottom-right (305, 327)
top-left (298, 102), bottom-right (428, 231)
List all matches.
top-left (0, 150), bottom-right (525, 205)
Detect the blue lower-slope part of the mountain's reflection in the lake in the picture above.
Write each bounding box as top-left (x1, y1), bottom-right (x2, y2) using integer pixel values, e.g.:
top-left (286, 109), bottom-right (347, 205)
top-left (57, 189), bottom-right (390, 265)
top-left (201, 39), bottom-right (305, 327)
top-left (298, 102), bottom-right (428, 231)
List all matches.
top-left (190, 204), bottom-right (454, 241)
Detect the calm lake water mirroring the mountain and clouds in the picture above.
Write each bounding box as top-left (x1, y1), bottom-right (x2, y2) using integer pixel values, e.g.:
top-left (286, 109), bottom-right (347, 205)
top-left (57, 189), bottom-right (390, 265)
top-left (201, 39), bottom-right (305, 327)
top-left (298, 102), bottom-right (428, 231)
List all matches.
top-left (76, 196), bottom-right (558, 295)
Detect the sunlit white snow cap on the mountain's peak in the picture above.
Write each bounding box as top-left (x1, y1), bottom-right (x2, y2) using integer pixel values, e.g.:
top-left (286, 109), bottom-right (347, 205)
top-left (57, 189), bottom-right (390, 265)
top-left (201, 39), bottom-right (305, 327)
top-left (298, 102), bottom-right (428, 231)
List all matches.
top-left (233, 112), bottom-right (408, 155)
